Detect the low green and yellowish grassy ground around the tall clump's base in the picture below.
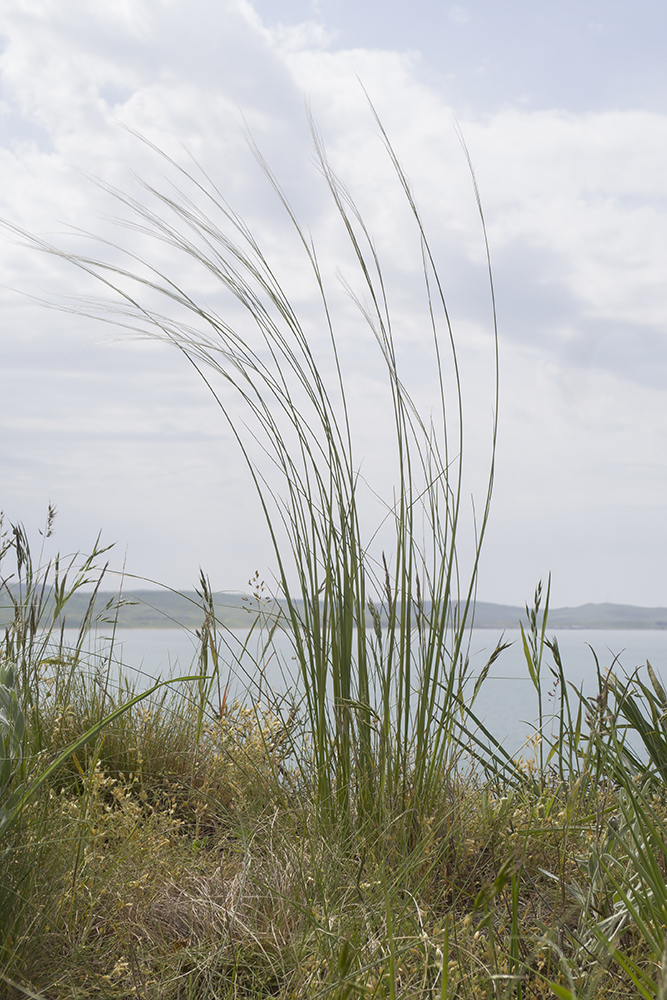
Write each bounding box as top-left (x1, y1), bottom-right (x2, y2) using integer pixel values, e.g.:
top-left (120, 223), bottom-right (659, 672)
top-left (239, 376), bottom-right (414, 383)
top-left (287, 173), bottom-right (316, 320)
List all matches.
top-left (0, 576), bottom-right (667, 1000)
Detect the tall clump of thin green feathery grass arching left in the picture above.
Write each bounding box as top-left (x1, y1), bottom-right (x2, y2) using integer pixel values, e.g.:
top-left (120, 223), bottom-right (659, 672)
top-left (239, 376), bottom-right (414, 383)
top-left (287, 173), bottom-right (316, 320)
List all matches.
top-left (14, 117), bottom-right (498, 842)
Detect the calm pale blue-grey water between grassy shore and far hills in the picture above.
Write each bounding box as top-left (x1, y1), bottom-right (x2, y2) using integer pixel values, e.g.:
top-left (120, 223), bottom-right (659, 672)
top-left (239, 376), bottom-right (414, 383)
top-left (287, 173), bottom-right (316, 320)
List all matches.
top-left (56, 629), bottom-right (667, 753)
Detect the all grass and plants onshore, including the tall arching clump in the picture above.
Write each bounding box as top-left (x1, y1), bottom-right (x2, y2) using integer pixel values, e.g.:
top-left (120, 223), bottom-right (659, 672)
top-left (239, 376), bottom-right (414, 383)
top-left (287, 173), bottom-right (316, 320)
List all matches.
top-left (0, 113), bottom-right (667, 1000)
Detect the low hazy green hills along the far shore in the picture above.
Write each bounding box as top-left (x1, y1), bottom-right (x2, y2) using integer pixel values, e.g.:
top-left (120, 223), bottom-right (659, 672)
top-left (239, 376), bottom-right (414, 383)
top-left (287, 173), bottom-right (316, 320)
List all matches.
top-left (0, 590), bottom-right (667, 629)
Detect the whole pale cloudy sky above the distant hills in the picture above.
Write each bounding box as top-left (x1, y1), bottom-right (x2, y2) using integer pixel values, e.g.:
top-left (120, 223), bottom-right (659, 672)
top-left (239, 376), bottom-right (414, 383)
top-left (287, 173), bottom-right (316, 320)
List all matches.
top-left (0, 0), bottom-right (667, 606)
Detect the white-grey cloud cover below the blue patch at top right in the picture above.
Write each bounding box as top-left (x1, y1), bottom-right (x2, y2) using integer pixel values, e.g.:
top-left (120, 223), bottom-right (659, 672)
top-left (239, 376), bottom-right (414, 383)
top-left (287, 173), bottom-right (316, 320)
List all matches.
top-left (0, 0), bottom-right (667, 603)
